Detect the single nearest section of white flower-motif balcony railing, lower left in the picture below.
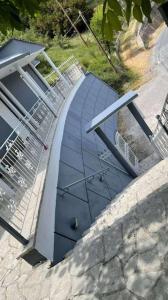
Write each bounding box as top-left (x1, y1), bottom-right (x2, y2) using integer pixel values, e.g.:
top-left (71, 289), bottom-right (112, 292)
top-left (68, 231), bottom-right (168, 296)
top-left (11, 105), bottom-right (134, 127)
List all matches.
top-left (0, 124), bottom-right (44, 235)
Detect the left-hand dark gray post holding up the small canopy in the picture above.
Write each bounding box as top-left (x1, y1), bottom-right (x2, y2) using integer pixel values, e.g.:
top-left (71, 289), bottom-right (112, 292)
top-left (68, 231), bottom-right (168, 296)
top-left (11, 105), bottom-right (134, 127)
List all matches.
top-left (95, 127), bottom-right (138, 178)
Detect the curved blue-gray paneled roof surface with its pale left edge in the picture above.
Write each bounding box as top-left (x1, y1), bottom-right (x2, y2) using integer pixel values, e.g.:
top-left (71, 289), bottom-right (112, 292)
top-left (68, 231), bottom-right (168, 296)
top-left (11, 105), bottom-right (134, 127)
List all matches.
top-left (35, 74), bottom-right (132, 262)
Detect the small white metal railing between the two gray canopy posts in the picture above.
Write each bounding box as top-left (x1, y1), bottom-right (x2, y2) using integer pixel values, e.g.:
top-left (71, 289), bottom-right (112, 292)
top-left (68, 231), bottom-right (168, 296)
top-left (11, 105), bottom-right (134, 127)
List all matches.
top-left (115, 131), bottom-right (139, 172)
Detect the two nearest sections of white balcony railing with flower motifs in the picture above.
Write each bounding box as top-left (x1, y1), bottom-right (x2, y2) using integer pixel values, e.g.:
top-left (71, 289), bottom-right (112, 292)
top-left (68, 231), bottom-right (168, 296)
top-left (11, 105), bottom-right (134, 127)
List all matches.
top-left (0, 95), bottom-right (54, 239)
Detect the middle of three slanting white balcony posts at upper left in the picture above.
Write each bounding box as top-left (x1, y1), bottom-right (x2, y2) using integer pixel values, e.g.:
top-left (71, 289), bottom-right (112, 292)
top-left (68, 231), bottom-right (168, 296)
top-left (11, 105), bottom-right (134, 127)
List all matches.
top-left (17, 66), bottom-right (57, 117)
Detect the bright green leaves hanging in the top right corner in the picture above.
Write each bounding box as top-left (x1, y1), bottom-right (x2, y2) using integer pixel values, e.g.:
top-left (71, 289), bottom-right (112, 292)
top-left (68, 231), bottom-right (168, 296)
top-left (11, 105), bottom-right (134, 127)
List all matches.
top-left (102, 0), bottom-right (166, 40)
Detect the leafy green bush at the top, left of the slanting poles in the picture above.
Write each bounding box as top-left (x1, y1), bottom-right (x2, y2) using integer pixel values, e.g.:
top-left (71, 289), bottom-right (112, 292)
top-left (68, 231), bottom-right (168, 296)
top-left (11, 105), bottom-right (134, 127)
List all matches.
top-left (32, 0), bottom-right (93, 38)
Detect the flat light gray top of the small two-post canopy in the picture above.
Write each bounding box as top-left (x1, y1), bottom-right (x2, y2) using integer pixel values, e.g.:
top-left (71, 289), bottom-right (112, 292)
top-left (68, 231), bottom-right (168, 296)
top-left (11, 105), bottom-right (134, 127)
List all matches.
top-left (86, 91), bottom-right (138, 133)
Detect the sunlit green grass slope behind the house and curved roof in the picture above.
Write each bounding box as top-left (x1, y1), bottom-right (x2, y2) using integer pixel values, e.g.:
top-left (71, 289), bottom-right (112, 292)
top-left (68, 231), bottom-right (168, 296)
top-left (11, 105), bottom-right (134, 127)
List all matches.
top-left (0, 29), bottom-right (137, 94)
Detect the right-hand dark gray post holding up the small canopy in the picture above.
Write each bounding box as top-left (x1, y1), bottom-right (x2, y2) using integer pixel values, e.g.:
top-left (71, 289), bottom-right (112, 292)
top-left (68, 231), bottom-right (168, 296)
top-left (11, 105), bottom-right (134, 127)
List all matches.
top-left (127, 102), bottom-right (153, 140)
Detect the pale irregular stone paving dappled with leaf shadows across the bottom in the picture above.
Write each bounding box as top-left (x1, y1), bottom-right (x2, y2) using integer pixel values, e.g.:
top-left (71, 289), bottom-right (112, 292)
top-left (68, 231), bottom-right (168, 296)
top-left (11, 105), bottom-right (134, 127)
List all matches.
top-left (0, 159), bottom-right (168, 300)
